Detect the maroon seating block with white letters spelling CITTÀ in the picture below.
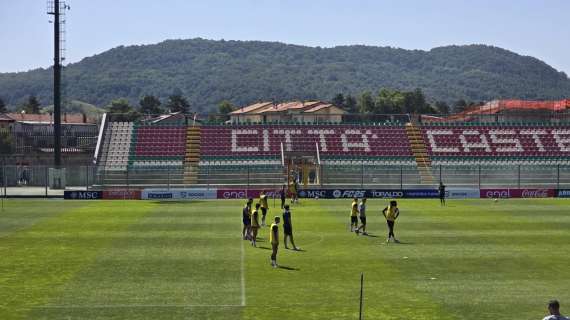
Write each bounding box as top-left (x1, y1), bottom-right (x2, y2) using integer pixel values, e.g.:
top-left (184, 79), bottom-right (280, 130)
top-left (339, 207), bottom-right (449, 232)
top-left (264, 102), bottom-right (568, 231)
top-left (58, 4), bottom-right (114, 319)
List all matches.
top-left (197, 125), bottom-right (412, 161)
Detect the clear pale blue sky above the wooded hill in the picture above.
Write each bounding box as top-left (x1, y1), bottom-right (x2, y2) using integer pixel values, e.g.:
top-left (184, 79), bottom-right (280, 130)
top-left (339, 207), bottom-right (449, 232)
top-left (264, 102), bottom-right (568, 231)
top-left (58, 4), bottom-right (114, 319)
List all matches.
top-left (0, 0), bottom-right (570, 74)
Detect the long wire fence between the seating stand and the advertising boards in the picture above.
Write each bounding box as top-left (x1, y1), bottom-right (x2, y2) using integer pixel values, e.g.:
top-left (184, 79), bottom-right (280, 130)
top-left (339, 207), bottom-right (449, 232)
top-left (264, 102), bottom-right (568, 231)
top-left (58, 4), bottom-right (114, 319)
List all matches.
top-left (0, 163), bottom-right (570, 197)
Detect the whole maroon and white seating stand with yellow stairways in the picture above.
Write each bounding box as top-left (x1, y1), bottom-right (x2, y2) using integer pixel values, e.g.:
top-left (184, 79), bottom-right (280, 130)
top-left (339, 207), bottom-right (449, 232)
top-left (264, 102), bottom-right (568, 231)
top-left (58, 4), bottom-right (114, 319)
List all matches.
top-left (95, 115), bottom-right (570, 186)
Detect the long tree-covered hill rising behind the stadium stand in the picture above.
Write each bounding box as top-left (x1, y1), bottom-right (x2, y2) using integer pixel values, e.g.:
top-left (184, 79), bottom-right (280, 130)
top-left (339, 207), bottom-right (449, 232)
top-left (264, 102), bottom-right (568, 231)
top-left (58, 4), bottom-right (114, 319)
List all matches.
top-left (0, 39), bottom-right (570, 111)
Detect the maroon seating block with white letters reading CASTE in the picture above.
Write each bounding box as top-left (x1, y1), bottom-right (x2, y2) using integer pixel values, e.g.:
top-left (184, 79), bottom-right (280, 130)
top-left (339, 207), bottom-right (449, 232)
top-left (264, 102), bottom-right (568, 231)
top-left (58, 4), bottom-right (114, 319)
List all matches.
top-left (422, 124), bottom-right (570, 165)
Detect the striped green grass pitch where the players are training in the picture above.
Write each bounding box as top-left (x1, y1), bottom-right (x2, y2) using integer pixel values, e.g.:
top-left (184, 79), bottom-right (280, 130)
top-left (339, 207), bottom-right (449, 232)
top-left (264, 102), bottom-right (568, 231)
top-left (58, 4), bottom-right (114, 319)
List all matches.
top-left (0, 199), bottom-right (570, 320)
